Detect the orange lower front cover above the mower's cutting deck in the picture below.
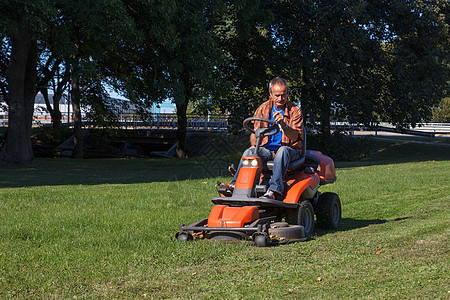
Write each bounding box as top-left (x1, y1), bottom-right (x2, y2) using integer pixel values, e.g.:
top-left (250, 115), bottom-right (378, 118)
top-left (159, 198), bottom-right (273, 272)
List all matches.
top-left (208, 205), bottom-right (259, 227)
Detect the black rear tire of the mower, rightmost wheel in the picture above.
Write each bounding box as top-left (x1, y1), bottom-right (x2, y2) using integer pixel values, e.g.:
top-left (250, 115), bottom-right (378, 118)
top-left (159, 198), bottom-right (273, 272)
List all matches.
top-left (316, 193), bottom-right (342, 230)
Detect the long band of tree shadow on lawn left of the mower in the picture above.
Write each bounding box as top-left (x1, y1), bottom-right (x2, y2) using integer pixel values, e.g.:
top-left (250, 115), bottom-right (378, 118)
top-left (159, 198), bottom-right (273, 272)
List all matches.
top-left (0, 159), bottom-right (239, 188)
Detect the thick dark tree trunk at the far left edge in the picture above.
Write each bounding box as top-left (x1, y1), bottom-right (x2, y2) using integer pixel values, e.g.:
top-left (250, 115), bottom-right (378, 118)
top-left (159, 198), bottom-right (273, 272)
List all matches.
top-left (0, 29), bottom-right (38, 163)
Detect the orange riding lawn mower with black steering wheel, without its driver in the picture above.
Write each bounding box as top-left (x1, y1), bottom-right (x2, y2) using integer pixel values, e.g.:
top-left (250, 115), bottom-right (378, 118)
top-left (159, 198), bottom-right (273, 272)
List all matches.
top-left (175, 117), bottom-right (341, 247)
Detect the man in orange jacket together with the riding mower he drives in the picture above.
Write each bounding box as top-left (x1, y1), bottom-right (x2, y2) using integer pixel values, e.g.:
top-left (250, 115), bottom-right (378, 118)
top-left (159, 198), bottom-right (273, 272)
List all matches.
top-left (176, 78), bottom-right (341, 247)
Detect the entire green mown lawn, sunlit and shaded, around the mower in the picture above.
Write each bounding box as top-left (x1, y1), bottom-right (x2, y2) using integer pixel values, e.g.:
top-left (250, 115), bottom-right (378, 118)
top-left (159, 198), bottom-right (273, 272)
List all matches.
top-left (0, 142), bottom-right (450, 299)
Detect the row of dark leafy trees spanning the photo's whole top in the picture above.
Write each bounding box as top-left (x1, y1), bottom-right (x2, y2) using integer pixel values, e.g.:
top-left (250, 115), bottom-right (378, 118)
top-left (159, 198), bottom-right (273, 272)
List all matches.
top-left (0, 0), bottom-right (449, 162)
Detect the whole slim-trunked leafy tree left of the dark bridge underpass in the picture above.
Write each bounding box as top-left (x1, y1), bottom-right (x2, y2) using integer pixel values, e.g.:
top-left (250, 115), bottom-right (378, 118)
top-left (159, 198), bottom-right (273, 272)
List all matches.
top-left (49, 0), bottom-right (133, 158)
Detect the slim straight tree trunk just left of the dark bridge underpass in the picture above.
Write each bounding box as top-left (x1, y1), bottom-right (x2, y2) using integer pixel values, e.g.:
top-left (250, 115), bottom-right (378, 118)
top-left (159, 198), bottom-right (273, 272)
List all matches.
top-left (71, 72), bottom-right (83, 158)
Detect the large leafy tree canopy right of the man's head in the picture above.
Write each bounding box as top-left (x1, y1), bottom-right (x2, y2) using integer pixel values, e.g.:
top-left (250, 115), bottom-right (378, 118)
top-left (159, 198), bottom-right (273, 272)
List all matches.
top-left (255, 0), bottom-right (449, 135)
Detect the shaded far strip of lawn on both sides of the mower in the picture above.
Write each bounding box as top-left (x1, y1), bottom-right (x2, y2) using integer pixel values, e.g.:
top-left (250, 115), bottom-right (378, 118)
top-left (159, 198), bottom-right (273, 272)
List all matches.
top-left (0, 137), bottom-right (450, 188)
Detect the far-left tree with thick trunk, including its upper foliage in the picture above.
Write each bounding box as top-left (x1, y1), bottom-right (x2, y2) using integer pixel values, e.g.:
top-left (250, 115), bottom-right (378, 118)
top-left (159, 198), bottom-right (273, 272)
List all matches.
top-left (0, 0), bottom-right (55, 163)
